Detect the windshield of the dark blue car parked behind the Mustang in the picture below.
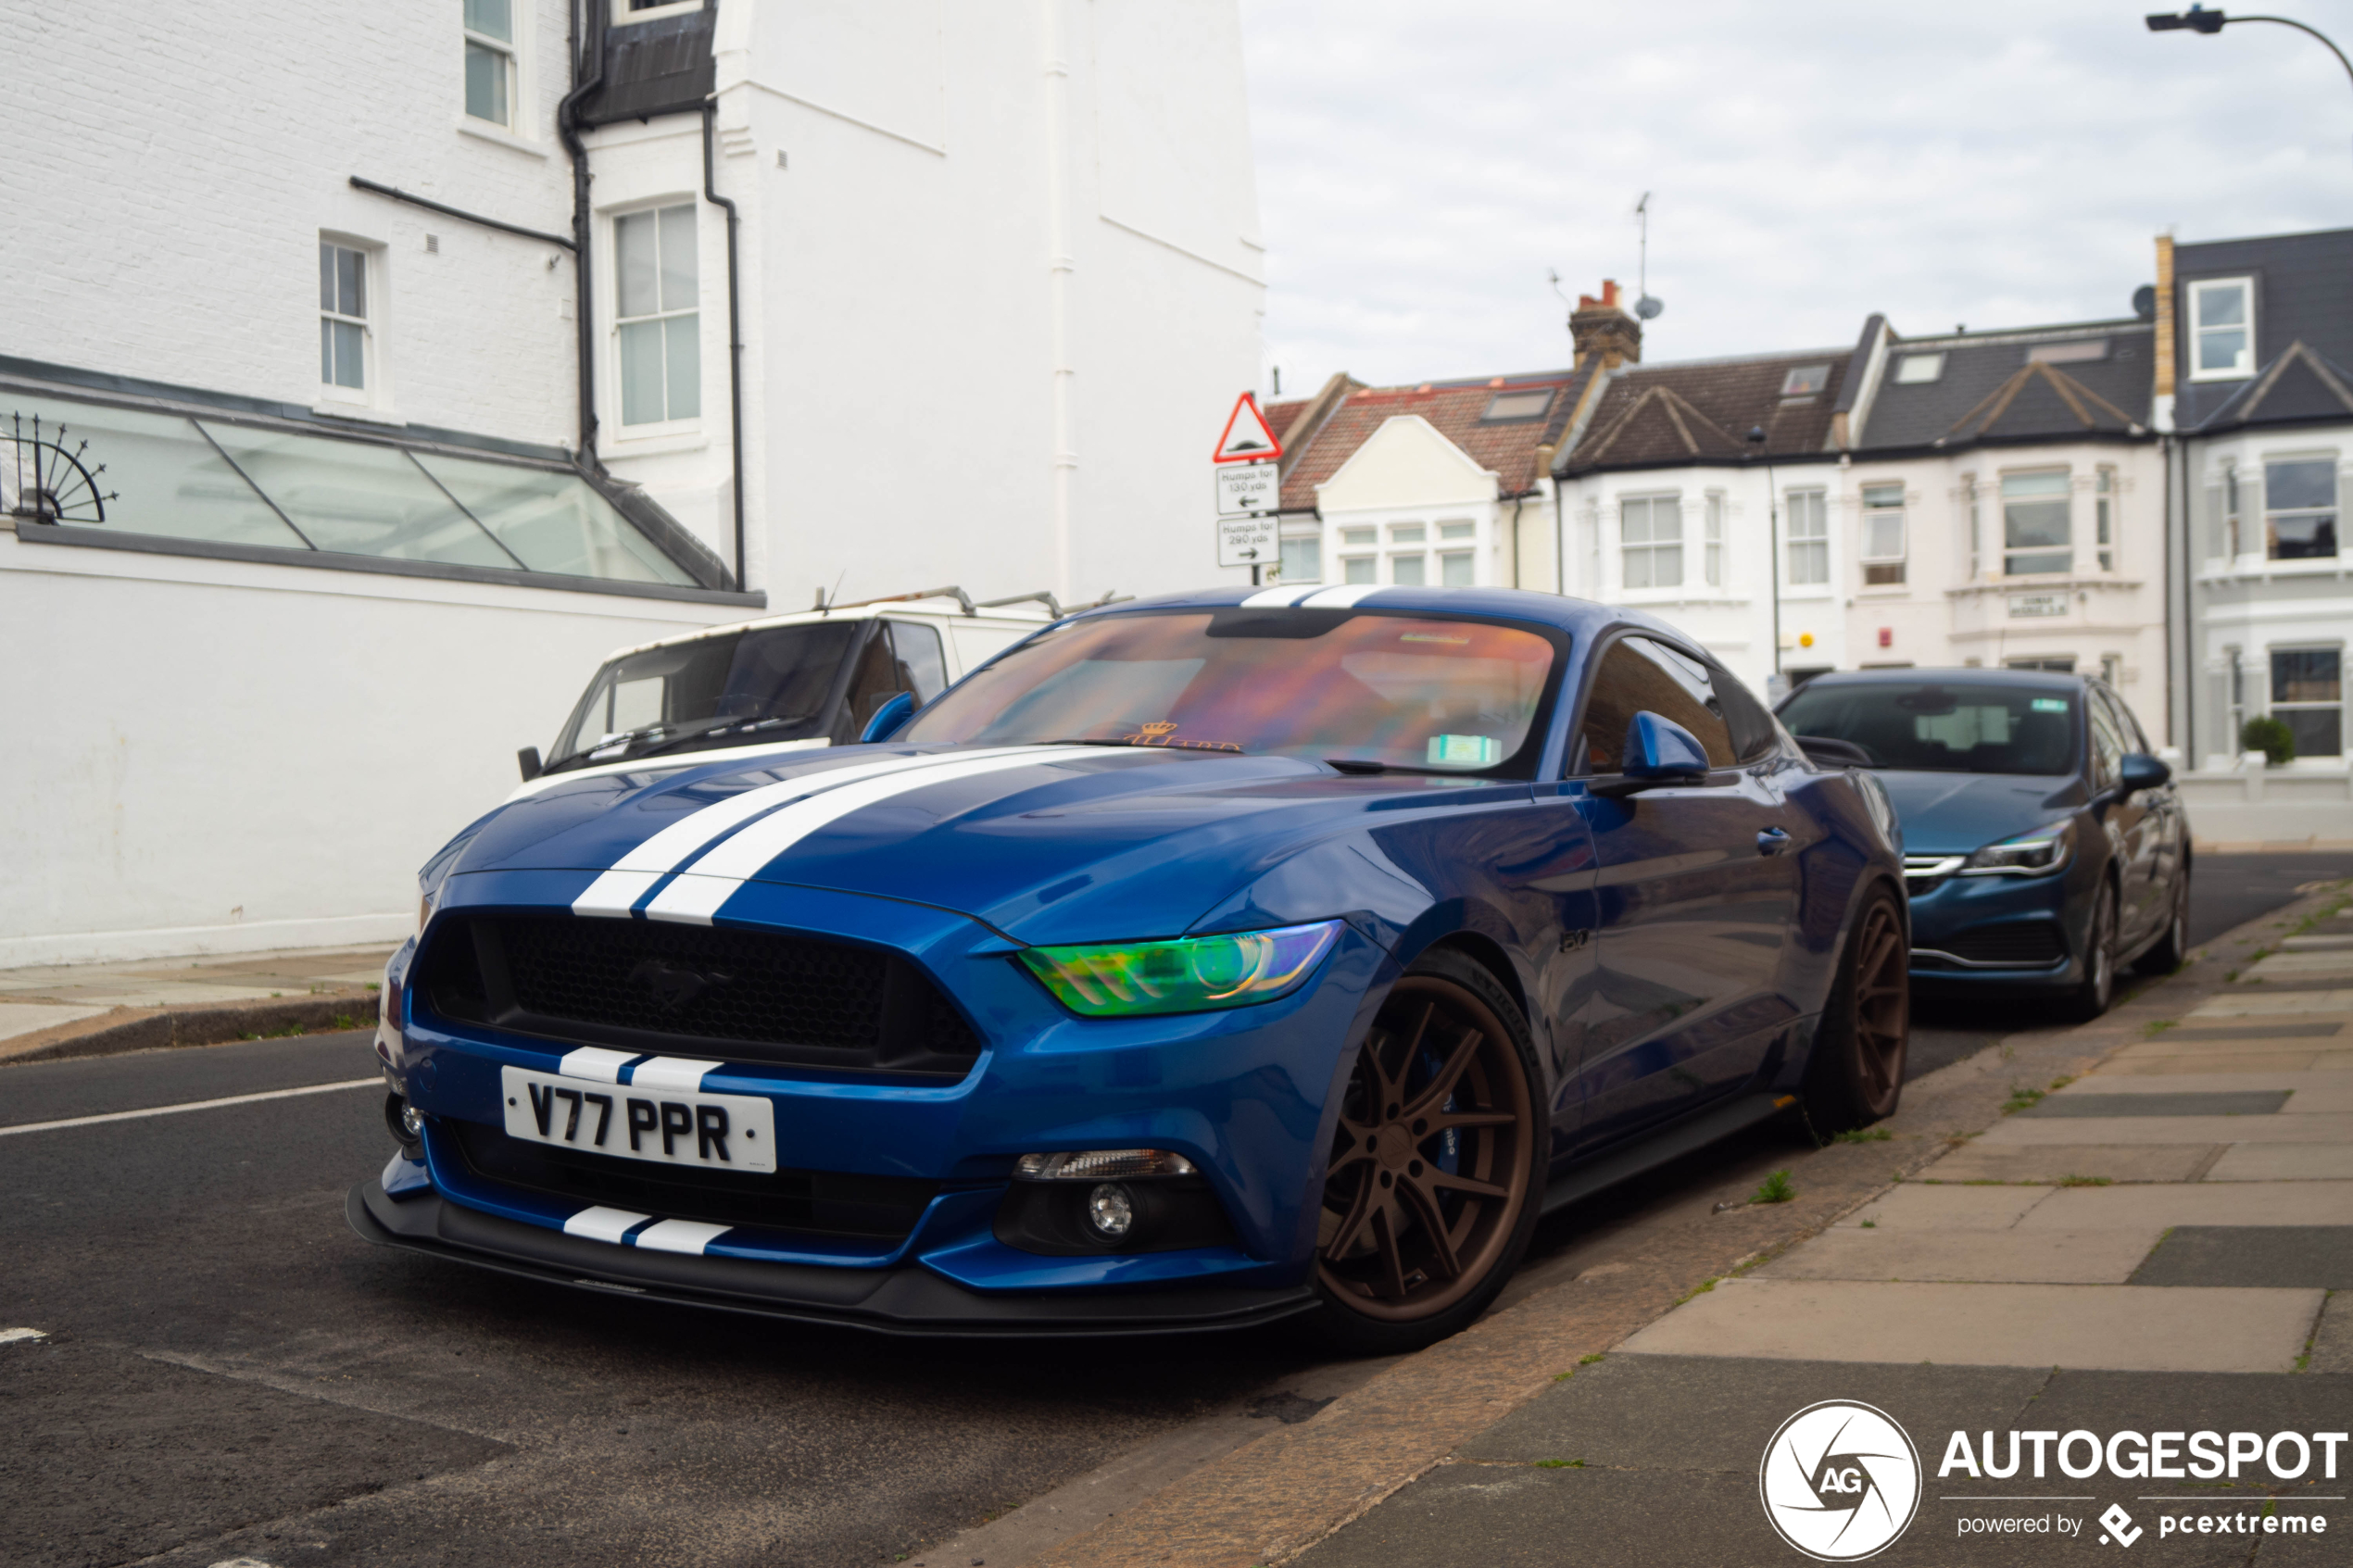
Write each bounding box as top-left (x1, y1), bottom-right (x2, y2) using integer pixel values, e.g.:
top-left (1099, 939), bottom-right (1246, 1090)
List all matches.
top-left (1781, 682), bottom-right (2080, 773)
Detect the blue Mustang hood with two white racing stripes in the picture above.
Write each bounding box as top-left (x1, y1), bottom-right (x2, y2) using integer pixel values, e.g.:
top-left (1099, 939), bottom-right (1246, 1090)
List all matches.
top-left (442, 746), bottom-right (1527, 943)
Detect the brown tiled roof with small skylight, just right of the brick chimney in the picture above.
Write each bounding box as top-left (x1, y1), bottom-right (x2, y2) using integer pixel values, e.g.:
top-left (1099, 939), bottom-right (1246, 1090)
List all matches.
top-left (1557, 348), bottom-right (1855, 475)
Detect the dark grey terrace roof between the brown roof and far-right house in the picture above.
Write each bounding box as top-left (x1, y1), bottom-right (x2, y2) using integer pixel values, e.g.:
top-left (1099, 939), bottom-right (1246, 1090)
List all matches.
top-left (1849, 322), bottom-right (2156, 451)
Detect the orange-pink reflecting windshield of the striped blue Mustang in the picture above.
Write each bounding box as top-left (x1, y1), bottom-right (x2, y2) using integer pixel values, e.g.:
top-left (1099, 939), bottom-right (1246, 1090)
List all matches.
top-left (899, 608), bottom-right (1557, 776)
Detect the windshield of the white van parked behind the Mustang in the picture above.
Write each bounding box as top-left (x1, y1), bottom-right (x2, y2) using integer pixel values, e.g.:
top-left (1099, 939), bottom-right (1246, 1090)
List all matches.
top-left (548, 621), bottom-right (866, 773)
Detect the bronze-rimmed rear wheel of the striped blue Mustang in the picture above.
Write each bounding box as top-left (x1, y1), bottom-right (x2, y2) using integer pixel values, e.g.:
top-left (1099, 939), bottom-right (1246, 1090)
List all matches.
top-left (1800, 886), bottom-right (1910, 1138)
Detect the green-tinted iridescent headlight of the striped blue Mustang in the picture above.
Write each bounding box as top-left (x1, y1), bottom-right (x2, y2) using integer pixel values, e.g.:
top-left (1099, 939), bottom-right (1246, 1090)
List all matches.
top-left (1021, 919), bottom-right (1341, 1018)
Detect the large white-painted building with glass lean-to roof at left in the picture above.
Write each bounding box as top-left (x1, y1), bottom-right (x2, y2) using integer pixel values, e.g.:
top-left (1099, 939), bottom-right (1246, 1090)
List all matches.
top-left (0, 0), bottom-right (1264, 966)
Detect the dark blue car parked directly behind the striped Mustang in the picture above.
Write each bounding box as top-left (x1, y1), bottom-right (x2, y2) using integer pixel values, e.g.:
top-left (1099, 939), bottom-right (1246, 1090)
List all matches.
top-left (1781, 670), bottom-right (2191, 1018)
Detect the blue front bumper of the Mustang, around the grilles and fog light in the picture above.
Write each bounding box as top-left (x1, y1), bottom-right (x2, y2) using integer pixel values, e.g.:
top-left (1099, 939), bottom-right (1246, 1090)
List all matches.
top-left (376, 874), bottom-right (1390, 1333)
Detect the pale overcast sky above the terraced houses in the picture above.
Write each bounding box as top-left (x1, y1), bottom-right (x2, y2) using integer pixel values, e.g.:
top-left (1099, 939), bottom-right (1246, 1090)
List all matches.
top-left (1242, 0), bottom-right (2353, 395)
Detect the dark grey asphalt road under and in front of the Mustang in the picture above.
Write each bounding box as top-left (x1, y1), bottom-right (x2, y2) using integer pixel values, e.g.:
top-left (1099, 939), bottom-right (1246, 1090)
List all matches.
top-left (0, 856), bottom-right (2353, 1568)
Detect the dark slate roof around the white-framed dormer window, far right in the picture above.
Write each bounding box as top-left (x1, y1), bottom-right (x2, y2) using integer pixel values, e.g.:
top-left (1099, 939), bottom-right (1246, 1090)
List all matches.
top-left (2174, 228), bottom-right (2353, 430)
